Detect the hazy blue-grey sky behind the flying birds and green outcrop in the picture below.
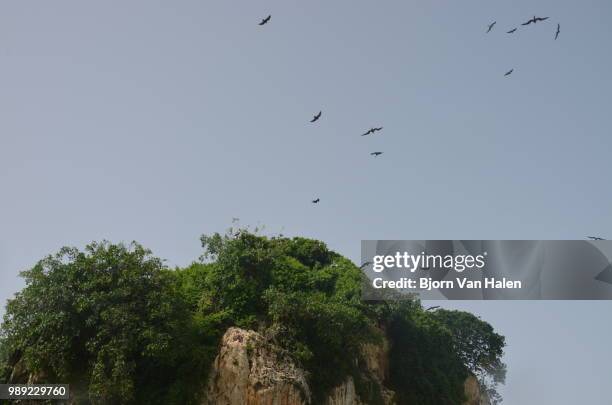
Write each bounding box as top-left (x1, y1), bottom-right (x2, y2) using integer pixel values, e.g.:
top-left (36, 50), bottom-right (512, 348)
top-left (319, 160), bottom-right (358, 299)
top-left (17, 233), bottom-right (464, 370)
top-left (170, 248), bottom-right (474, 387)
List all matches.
top-left (0, 0), bottom-right (612, 405)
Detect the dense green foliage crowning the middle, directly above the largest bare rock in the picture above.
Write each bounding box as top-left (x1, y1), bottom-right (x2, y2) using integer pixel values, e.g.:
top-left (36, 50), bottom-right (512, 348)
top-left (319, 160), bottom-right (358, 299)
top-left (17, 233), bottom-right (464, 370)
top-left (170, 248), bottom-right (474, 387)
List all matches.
top-left (189, 232), bottom-right (380, 395)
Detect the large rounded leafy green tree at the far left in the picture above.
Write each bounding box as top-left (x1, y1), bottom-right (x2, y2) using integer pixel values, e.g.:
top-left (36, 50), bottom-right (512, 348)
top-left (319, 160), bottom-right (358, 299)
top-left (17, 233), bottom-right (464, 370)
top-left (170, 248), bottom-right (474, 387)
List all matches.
top-left (2, 242), bottom-right (201, 404)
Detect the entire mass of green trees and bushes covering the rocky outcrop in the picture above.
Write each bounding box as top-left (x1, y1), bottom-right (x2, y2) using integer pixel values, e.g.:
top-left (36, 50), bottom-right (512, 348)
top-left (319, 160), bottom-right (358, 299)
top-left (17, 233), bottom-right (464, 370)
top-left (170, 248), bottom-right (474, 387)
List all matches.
top-left (0, 230), bottom-right (504, 404)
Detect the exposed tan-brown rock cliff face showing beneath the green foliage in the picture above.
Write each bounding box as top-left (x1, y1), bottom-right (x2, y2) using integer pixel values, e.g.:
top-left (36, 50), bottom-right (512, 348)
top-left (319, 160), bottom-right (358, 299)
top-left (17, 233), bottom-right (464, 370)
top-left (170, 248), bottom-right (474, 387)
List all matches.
top-left (202, 328), bottom-right (485, 405)
